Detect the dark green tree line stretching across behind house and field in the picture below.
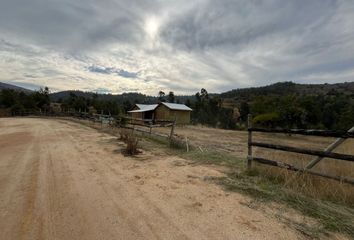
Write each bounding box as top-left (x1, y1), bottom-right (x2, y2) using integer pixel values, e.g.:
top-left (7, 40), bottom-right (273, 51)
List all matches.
top-left (0, 87), bottom-right (354, 130)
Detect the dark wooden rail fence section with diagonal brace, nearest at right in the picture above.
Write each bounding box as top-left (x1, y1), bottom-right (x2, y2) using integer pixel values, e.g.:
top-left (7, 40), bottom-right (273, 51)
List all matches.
top-left (247, 115), bottom-right (354, 184)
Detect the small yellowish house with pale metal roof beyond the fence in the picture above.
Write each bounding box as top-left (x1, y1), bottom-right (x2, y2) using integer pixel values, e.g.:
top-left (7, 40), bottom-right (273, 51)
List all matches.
top-left (128, 102), bottom-right (192, 124)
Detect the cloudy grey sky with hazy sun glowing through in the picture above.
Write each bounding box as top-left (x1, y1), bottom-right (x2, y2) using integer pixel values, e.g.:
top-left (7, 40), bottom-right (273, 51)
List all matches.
top-left (0, 0), bottom-right (354, 95)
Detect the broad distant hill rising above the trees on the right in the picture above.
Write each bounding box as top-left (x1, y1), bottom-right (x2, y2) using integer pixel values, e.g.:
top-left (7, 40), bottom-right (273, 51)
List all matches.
top-left (219, 82), bottom-right (354, 101)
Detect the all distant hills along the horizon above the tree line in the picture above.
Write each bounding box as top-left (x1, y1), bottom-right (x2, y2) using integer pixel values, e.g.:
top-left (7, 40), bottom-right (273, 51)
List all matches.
top-left (0, 82), bottom-right (354, 106)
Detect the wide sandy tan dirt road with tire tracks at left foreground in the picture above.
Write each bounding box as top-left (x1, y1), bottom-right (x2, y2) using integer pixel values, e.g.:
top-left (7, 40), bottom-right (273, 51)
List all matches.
top-left (0, 118), bottom-right (303, 240)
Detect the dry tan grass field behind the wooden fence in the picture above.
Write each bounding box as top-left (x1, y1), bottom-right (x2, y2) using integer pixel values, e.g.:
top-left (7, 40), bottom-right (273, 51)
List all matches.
top-left (62, 117), bottom-right (354, 206)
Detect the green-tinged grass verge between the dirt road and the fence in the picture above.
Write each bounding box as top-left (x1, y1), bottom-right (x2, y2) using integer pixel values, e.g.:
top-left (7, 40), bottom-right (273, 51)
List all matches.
top-left (143, 134), bottom-right (354, 239)
